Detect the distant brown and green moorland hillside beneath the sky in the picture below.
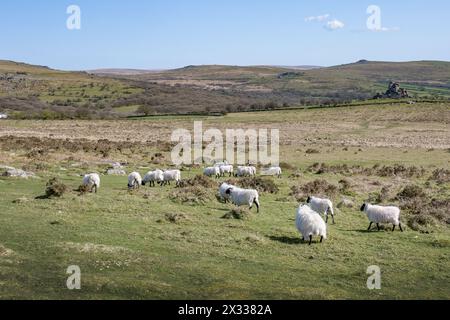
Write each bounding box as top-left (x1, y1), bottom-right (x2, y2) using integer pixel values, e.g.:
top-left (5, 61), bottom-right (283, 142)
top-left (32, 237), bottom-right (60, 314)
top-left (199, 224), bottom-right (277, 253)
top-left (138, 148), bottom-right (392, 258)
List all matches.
top-left (0, 60), bottom-right (450, 118)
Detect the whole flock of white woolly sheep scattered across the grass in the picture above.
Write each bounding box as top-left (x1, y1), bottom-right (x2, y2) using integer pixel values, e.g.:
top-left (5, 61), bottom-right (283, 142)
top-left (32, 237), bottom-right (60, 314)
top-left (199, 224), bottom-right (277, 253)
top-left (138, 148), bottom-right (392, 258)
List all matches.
top-left (83, 161), bottom-right (403, 245)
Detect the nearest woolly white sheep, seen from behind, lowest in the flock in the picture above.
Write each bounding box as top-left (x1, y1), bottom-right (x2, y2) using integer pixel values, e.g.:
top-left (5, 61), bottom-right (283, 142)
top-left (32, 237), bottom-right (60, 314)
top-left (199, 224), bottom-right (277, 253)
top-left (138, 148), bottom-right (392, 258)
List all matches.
top-left (295, 205), bottom-right (327, 245)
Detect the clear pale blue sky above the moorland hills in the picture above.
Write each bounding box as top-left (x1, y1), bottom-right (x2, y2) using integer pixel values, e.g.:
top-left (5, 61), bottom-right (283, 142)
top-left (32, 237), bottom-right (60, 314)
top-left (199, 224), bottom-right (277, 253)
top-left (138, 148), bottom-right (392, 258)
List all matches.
top-left (0, 0), bottom-right (450, 70)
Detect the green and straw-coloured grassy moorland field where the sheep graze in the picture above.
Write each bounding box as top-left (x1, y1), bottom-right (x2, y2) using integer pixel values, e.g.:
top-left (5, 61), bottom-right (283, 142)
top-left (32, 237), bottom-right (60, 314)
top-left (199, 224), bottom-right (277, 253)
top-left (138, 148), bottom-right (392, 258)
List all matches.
top-left (0, 104), bottom-right (450, 299)
